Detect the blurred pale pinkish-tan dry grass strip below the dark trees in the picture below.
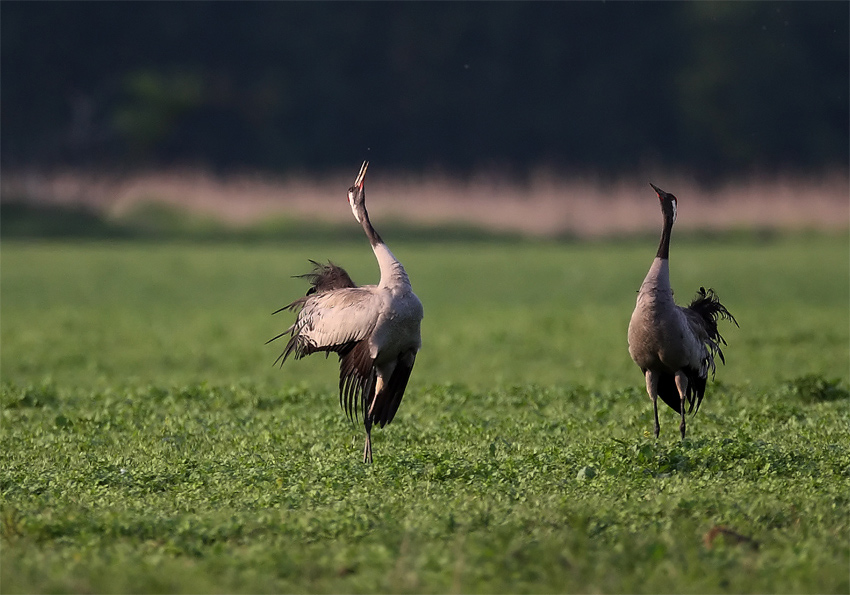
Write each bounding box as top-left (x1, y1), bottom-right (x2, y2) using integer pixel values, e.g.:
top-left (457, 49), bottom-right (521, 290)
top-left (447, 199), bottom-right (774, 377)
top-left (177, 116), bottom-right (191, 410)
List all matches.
top-left (2, 167), bottom-right (850, 237)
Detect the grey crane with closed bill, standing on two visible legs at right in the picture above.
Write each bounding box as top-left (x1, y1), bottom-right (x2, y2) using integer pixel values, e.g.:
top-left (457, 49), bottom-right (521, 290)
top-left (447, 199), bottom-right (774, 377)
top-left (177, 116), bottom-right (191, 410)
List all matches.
top-left (628, 183), bottom-right (738, 440)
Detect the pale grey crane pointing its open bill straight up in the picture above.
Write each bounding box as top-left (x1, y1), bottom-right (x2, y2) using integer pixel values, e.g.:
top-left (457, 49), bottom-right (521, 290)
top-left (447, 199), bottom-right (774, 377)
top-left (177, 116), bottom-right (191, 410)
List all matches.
top-left (266, 161), bottom-right (423, 463)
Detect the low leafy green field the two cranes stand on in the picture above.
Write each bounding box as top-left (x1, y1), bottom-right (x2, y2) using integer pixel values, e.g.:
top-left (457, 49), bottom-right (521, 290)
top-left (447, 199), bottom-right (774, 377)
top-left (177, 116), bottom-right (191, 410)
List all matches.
top-left (0, 232), bottom-right (850, 593)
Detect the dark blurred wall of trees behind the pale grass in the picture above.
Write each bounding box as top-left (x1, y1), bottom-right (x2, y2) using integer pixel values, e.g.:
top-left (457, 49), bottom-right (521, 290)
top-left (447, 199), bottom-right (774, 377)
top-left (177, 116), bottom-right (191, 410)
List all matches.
top-left (0, 1), bottom-right (850, 179)
